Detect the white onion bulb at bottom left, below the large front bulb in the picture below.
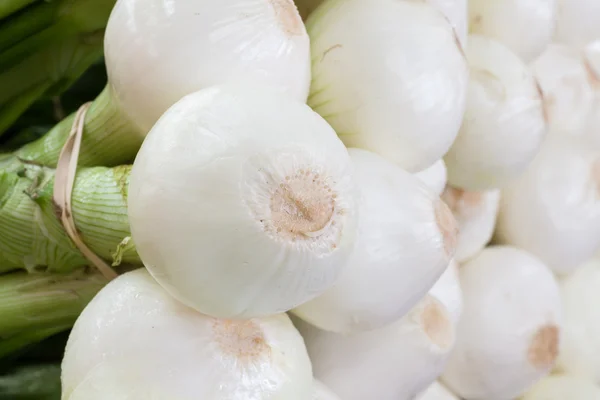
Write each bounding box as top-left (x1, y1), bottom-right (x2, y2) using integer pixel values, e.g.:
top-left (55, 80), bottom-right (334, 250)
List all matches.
top-left (62, 268), bottom-right (313, 400)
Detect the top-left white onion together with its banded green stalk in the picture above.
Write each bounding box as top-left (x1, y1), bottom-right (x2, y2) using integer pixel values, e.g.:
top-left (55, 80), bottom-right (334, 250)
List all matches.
top-left (8, 0), bottom-right (310, 166)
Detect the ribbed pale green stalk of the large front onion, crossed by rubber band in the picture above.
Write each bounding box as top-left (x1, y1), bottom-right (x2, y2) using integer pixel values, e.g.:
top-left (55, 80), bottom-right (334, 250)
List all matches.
top-left (0, 161), bottom-right (141, 273)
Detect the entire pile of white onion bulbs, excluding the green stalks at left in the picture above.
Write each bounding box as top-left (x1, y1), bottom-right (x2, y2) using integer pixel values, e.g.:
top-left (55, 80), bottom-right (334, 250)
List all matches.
top-left (62, 0), bottom-right (600, 400)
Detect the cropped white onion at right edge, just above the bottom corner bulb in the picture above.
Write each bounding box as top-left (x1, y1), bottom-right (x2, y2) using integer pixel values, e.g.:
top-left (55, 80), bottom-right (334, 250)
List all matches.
top-left (557, 258), bottom-right (600, 382)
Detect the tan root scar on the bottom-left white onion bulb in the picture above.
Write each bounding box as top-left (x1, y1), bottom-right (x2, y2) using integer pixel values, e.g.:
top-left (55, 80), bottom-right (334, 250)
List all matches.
top-left (213, 319), bottom-right (271, 362)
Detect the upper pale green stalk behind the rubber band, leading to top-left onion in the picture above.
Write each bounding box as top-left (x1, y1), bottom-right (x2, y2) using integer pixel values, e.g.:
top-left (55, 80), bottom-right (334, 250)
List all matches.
top-left (15, 86), bottom-right (143, 167)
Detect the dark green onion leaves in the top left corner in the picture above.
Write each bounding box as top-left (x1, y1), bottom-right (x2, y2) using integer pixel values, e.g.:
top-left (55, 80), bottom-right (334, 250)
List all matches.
top-left (0, 0), bottom-right (115, 135)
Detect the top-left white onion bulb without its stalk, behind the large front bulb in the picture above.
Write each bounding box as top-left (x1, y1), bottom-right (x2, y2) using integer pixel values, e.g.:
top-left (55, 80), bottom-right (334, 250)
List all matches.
top-left (104, 0), bottom-right (310, 134)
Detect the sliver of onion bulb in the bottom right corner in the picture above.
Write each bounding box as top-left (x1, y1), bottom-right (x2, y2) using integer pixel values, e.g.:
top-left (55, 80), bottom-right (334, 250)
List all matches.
top-left (521, 375), bottom-right (600, 400)
